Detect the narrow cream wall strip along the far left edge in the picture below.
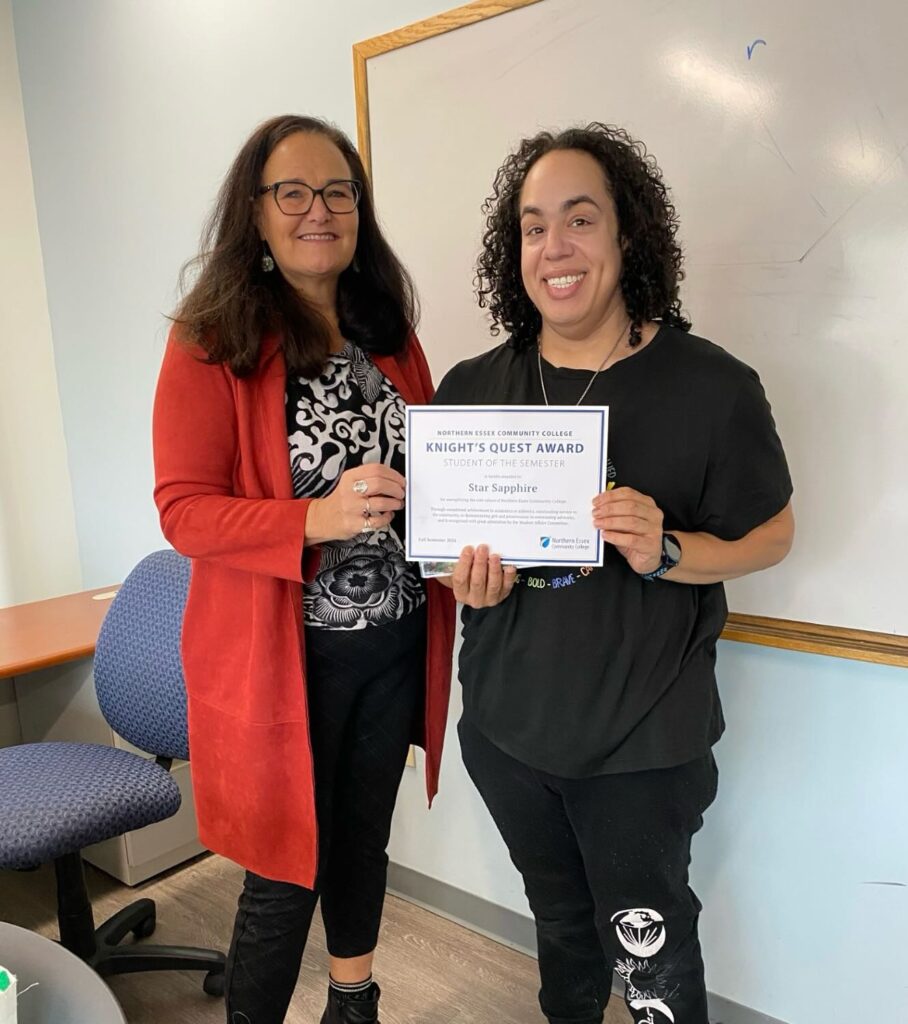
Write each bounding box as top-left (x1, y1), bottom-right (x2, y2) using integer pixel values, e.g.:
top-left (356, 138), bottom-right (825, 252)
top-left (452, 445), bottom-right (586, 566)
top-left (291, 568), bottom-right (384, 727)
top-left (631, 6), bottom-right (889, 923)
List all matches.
top-left (0, 0), bottom-right (81, 746)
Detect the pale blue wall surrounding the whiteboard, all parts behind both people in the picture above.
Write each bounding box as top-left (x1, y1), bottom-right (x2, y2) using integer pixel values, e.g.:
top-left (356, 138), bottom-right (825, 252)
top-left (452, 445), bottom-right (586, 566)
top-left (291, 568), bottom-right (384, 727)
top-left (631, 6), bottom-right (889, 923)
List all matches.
top-left (3, 0), bottom-right (908, 1024)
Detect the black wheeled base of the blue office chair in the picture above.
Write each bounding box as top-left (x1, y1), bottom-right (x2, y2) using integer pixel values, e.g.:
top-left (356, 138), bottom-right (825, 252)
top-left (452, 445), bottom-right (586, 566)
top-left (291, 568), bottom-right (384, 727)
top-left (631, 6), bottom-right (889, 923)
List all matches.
top-left (55, 853), bottom-right (226, 995)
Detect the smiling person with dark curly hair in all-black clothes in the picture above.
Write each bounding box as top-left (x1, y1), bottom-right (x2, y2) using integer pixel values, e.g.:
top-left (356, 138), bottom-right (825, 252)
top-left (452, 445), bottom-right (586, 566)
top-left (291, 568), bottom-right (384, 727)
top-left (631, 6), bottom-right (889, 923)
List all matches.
top-left (435, 124), bottom-right (793, 1024)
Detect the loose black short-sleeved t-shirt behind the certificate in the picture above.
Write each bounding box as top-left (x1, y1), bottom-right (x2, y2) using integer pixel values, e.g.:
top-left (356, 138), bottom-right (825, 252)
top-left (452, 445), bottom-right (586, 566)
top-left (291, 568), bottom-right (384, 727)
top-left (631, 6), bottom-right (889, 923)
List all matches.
top-left (434, 326), bottom-right (791, 778)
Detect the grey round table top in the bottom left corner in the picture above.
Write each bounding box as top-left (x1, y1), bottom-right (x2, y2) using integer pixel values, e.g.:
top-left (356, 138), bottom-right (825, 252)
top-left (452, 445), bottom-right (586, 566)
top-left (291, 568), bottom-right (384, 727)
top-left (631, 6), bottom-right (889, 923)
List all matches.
top-left (0, 922), bottom-right (126, 1024)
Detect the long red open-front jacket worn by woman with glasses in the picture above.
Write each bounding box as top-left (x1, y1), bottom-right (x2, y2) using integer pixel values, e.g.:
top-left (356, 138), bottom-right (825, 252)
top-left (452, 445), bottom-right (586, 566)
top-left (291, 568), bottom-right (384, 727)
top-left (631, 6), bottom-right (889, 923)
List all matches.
top-left (154, 331), bottom-right (455, 888)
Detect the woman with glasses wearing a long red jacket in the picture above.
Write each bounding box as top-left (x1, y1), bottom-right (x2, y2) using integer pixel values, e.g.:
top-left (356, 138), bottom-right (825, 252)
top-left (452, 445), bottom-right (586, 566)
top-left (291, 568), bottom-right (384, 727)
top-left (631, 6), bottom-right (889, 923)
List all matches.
top-left (154, 116), bottom-right (453, 1024)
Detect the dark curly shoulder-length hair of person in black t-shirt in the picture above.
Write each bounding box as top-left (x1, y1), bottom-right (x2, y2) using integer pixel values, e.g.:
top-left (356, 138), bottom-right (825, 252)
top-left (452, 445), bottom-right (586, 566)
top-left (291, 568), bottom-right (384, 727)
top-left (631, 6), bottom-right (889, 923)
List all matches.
top-left (475, 121), bottom-right (691, 348)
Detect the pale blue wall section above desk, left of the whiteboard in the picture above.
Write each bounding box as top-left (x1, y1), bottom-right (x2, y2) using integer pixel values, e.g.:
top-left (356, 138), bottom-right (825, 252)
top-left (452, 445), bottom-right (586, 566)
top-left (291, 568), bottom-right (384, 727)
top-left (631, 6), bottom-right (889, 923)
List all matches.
top-left (13, 0), bottom-right (448, 587)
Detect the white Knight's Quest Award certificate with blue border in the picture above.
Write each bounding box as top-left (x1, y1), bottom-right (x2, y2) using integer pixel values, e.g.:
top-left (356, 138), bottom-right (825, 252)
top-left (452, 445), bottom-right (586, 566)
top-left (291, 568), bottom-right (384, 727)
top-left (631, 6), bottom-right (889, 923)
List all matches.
top-left (406, 406), bottom-right (608, 565)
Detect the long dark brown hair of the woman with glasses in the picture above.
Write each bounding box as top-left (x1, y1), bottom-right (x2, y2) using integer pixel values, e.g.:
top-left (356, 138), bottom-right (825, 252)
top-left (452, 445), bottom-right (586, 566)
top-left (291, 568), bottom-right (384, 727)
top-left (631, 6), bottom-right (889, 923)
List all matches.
top-left (173, 115), bottom-right (419, 378)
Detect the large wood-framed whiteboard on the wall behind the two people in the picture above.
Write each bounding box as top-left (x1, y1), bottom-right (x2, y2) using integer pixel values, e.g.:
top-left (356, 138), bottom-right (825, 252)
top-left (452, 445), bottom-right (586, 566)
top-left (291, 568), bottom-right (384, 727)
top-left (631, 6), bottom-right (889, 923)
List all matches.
top-left (369, 0), bottom-right (908, 634)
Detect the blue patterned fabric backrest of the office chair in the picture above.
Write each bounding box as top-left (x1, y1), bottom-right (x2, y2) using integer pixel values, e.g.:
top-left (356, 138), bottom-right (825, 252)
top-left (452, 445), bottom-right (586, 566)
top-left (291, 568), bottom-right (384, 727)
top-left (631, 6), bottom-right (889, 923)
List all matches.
top-left (94, 550), bottom-right (189, 758)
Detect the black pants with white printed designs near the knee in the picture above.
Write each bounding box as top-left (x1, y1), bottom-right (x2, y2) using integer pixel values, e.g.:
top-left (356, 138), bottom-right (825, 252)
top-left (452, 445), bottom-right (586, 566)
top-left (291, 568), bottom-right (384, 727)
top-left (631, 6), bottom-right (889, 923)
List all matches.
top-left (459, 720), bottom-right (718, 1024)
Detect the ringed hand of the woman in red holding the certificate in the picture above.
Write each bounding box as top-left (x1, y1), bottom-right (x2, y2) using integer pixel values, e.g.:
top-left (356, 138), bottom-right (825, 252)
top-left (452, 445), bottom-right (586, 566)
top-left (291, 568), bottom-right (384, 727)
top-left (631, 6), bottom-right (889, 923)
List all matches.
top-left (306, 463), bottom-right (405, 547)
